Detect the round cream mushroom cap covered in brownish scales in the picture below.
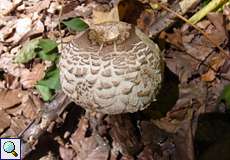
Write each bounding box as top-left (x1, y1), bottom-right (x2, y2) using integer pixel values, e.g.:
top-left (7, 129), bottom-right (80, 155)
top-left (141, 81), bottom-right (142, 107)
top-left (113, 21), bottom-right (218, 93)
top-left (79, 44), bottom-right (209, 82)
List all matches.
top-left (59, 23), bottom-right (164, 114)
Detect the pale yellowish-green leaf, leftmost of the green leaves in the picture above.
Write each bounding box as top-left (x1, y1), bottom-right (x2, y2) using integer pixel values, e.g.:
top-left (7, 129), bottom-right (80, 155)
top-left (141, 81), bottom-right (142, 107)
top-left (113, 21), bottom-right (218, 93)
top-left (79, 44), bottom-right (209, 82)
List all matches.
top-left (15, 38), bottom-right (39, 63)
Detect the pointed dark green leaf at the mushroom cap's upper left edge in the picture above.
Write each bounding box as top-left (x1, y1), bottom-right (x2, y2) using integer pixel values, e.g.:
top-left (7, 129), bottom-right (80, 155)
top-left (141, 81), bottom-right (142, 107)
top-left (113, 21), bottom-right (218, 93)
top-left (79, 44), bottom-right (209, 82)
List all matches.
top-left (62, 18), bottom-right (89, 32)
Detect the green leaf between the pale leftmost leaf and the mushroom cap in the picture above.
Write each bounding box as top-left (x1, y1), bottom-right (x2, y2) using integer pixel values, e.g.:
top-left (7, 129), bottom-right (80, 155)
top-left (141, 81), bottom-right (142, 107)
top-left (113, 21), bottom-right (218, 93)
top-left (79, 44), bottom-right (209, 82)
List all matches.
top-left (38, 39), bottom-right (58, 61)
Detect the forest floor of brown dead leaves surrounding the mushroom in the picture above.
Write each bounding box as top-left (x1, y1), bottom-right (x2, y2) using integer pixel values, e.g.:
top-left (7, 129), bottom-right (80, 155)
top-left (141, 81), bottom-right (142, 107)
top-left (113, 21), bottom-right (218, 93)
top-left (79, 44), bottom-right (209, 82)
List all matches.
top-left (0, 0), bottom-right (230, 160)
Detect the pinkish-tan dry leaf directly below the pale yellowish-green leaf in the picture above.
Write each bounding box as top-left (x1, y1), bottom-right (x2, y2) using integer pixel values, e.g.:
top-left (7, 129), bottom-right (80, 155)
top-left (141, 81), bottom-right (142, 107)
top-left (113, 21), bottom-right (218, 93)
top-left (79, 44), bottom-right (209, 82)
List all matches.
top-left (20, 63), bottom-right (45, 88)
